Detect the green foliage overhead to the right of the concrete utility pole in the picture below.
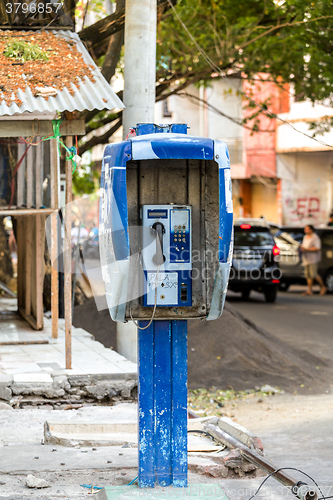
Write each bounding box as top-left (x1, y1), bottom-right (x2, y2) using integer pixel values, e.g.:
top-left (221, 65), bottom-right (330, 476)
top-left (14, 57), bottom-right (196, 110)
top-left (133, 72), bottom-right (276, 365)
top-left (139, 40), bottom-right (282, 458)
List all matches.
top-left (157, 0), bottom-right (333, 104)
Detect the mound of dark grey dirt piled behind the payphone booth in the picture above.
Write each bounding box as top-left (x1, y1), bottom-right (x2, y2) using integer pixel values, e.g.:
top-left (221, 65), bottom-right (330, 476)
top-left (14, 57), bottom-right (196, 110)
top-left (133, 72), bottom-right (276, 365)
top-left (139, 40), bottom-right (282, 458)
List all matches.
top-left (73, 299), bottom-right (333, 394)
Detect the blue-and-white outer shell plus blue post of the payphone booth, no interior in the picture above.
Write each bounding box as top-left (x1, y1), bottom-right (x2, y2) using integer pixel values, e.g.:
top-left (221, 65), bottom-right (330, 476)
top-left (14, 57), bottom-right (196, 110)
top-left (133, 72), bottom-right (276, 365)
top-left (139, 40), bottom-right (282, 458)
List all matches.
top-left (100, 124), bottom-right (233, 488)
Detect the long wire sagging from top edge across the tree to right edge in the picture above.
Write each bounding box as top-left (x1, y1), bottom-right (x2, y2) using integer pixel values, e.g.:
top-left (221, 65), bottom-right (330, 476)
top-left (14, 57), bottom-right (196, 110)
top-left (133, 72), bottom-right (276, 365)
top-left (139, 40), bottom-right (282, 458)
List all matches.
top-left (167, 0), bottom-right (333, 149)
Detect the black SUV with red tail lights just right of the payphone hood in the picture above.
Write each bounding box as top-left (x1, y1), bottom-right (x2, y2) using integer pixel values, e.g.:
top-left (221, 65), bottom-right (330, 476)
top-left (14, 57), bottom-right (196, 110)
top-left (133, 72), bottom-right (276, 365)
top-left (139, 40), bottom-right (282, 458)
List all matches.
top-left (229, 219), bottom-right (281, 302)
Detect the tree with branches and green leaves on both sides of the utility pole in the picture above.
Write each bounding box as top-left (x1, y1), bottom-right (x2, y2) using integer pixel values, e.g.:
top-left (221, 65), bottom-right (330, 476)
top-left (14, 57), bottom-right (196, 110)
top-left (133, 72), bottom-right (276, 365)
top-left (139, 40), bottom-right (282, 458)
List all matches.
top-left (18, 0), bottom-right (333, 152)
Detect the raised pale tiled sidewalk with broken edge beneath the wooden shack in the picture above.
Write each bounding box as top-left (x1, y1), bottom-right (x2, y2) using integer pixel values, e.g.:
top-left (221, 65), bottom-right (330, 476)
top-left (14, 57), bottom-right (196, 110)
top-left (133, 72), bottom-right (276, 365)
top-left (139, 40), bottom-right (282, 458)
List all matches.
top-left (0, 299), bottom-right (137, 404)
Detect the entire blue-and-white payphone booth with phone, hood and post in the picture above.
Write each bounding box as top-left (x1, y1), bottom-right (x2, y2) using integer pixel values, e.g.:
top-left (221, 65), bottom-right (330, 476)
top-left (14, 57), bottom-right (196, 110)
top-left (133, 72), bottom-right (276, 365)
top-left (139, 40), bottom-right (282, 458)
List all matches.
top-left (100, 124), bottom-right (233, 487)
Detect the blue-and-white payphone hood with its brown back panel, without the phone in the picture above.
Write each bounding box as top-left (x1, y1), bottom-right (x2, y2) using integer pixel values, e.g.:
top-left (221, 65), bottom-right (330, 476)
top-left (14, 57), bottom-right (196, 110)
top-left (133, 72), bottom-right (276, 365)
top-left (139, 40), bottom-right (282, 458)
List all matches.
top-left (99, 128), bottom-right (233, 322)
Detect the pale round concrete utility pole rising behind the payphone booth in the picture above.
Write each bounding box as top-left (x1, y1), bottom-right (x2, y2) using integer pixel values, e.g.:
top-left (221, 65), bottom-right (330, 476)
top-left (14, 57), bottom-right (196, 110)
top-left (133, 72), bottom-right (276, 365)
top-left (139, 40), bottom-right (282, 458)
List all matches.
top-left (117, 0), bottom-right (157, 363)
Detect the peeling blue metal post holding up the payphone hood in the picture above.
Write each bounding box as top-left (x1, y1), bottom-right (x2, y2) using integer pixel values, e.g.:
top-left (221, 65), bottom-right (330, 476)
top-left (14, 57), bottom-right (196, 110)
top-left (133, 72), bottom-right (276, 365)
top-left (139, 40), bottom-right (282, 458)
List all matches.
top-left (138, 320), bottom-right (187, 488)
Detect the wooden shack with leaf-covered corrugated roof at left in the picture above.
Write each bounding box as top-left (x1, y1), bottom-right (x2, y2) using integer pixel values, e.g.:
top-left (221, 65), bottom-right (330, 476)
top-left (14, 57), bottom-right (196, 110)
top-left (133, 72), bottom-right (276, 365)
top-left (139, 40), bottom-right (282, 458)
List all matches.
top-left (0, 29), bottom-right (123, 368)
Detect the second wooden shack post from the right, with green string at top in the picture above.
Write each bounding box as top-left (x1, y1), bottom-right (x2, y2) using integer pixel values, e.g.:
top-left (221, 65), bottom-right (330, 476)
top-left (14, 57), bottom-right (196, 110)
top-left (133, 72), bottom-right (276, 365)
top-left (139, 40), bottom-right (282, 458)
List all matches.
top-left (50, 139), bottom-right (59, 339)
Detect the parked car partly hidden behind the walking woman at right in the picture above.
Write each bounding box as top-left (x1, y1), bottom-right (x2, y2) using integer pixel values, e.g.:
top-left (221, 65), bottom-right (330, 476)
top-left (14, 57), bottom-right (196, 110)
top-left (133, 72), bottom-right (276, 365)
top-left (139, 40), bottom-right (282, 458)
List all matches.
top-left (274, 226), bottom-right (333, 293)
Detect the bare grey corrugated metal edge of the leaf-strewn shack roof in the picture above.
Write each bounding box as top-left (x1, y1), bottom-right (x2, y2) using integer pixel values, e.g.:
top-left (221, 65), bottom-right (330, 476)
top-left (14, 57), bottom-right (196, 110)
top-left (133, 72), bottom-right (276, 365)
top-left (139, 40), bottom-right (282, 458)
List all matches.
top-left (0, 30), bottom-right (124, 116)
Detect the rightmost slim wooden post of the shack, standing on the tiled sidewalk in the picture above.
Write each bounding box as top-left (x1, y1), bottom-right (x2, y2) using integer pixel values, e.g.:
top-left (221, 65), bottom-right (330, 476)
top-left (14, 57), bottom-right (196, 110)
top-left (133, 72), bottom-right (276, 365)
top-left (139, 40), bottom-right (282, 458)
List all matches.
top-left (64, 136), bottom-right (73, 369)
